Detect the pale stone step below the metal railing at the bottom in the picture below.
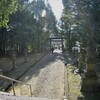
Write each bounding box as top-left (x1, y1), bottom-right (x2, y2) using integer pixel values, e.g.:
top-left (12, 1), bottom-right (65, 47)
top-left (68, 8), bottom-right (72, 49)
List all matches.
top-left (0, 92), bottom-right (58, 100)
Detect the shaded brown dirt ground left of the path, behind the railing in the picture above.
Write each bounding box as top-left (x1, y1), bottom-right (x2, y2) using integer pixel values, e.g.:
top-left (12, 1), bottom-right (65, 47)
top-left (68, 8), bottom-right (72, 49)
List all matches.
top-left (0, 53), bottom-right (46, 91)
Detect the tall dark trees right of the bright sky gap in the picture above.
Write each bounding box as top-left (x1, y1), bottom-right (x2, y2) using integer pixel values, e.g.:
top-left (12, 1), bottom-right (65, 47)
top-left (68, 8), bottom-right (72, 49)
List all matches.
top-left (62, 0), bottom-right (100, 51)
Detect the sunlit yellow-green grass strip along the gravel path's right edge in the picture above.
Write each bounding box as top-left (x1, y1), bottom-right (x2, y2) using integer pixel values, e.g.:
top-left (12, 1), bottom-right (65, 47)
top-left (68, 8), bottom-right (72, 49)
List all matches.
top-left (67, 65), bottom-right (82, 100)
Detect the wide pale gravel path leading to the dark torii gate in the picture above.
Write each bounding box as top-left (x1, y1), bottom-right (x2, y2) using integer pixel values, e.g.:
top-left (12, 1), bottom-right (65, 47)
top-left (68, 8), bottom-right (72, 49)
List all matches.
top-left (10, 51), bottom-right (64, 100)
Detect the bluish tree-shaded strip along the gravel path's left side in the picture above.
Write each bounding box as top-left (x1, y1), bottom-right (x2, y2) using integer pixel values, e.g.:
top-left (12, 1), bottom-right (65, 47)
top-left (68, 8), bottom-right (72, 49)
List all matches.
top-left (6, 52), bottom-right (63, 85)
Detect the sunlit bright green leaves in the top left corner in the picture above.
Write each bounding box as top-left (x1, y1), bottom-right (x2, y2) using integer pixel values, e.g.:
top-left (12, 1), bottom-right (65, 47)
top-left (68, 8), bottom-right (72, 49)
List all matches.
top-left (0, 0), bottom-right (18, 28)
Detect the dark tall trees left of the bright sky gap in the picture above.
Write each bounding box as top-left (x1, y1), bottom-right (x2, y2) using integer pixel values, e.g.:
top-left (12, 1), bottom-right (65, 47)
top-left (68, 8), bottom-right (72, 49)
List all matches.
top-left (0, 0), bottom-right (58, 54)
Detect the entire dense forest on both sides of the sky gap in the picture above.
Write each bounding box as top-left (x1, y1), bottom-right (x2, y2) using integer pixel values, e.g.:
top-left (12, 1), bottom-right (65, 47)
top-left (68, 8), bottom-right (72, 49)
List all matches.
top-left (0, 0), bottom-right (100, 58)
